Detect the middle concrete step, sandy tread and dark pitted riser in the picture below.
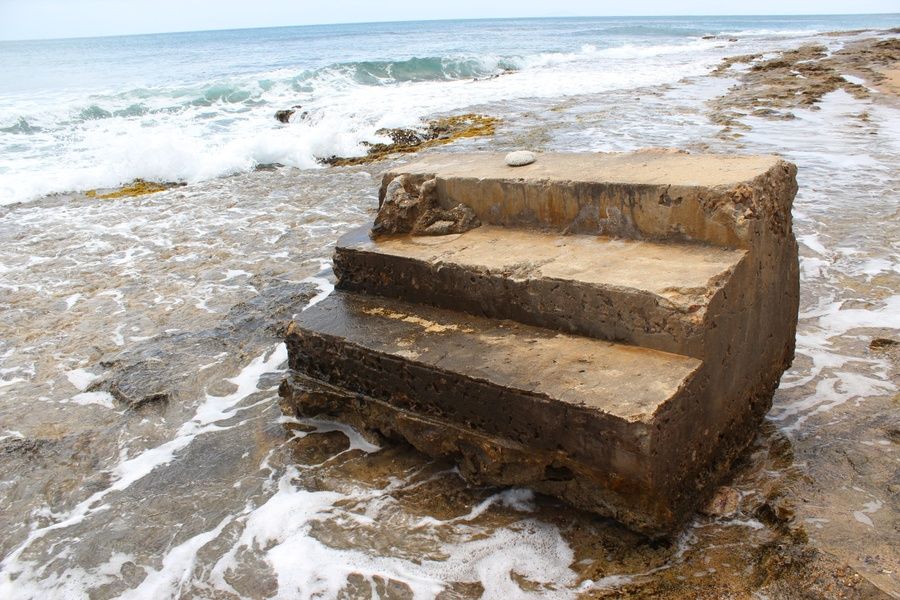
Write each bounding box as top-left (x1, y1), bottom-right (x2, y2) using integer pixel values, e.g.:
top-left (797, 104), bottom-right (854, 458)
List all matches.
top-left (334, 226), bottom-right (746, 358)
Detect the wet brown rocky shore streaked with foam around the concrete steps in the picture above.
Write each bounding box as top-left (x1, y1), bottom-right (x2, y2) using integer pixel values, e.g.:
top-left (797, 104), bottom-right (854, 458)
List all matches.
top-left (0, 27), bottom-right (900, 600)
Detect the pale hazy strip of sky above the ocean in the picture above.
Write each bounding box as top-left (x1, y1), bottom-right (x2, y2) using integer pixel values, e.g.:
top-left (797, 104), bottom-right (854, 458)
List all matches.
top-left (0, 0), bottom-right (900, 39)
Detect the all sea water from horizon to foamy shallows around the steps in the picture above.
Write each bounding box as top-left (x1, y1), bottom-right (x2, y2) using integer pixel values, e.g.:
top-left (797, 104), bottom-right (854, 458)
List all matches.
top-left (0, 15), bottom-right (900, 600)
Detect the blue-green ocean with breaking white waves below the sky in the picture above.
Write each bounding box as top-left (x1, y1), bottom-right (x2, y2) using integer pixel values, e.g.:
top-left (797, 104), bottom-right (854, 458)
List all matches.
top-left (0, 15), bottom-right (896, 204)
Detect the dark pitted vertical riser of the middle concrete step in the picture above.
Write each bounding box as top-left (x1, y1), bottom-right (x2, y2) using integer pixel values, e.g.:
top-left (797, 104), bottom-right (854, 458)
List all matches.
top-left (334, 246), bottom-right (706, 357)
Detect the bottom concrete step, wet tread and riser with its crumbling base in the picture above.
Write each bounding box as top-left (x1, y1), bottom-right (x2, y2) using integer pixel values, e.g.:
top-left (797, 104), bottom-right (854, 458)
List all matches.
top-left (282, 291), bottom-right (767, 535)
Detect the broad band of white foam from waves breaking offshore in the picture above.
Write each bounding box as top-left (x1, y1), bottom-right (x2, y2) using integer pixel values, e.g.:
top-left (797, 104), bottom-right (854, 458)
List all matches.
top-left (0, 40), bottom-right (732, 206)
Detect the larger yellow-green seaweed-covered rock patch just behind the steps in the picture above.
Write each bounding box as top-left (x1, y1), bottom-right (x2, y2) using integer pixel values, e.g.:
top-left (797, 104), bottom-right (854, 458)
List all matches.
top-left (319, 113), bottom-right (500, 167)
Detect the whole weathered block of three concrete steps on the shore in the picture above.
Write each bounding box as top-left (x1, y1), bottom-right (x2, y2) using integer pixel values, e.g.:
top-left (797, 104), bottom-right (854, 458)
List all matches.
top-left (281, 152), bottom-right (799, 536)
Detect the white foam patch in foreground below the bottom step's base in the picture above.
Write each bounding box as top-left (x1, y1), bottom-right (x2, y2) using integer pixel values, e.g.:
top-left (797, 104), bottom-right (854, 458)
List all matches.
top-left (210, 467), bottom-right (575, 599)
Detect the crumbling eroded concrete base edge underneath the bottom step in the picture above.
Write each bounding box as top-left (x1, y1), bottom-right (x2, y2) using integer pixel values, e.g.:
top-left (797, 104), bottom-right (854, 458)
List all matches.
top-left (279, 372), bottom-right (768, 538)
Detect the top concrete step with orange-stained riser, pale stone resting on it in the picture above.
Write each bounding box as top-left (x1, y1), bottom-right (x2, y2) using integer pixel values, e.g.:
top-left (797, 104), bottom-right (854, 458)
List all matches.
top-left (380, 155), bottom-right (797, 248)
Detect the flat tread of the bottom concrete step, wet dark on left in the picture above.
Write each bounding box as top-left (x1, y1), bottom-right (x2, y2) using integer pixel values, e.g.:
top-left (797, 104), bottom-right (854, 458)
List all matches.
top-left (288, 291), bottom-right (702, 421)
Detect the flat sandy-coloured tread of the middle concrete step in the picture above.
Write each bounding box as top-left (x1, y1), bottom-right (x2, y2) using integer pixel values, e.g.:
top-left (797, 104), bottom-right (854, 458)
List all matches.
top-left (338, 225), bottom-right (746, 311)
